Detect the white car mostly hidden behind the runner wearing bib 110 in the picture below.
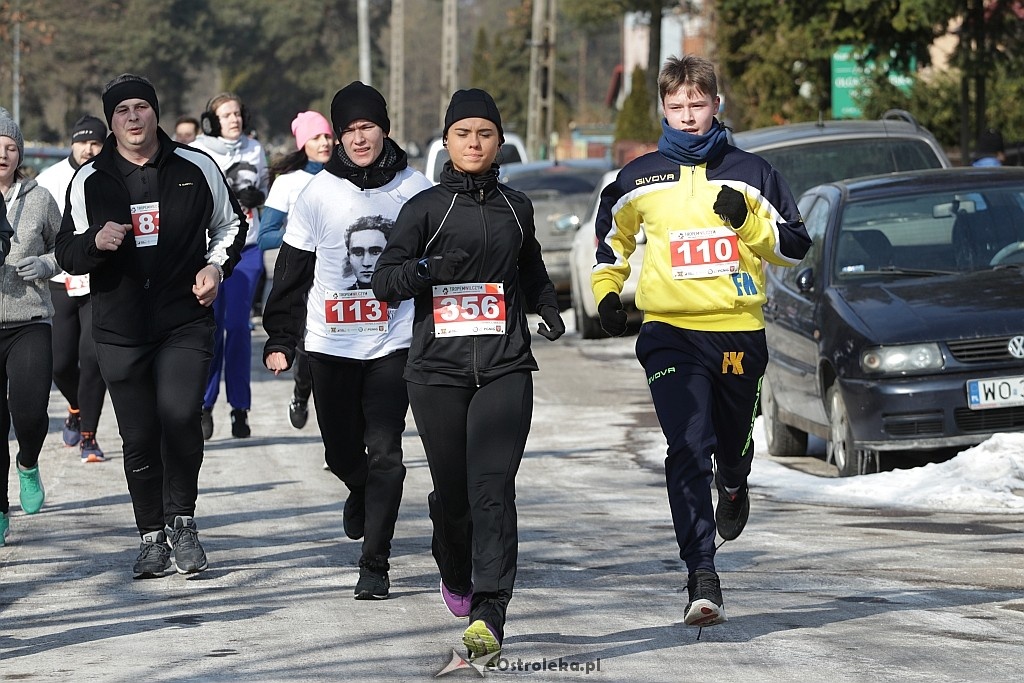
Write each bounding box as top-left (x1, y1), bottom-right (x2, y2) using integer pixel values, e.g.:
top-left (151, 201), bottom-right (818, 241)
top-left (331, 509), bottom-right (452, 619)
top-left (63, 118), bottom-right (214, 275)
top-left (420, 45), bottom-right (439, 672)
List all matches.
top-left (569, 165), bottom-right (647, 339)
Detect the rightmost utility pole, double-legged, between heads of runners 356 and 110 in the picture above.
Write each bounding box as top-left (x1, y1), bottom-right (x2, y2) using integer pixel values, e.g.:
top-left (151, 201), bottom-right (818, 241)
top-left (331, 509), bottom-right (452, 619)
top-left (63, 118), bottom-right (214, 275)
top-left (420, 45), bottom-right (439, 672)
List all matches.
top-left (526, 0), bottom-right (557, 159)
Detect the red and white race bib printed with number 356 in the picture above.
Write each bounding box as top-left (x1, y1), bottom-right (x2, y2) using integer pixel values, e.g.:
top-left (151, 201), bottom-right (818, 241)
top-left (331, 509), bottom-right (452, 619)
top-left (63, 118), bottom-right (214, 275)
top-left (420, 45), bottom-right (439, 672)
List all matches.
top-left (432, 283), bottom-right (507, 337)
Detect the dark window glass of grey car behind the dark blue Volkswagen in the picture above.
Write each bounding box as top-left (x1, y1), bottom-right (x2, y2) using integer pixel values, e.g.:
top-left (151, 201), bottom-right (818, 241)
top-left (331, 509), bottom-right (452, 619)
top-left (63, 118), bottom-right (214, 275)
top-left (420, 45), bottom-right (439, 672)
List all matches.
top-left (757, 137), bottom-right (942, 197)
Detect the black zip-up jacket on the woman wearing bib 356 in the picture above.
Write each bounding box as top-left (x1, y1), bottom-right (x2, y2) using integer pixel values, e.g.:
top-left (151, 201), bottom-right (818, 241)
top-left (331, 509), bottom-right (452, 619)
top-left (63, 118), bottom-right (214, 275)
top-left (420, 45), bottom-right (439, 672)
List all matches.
top-left (371, 162), bottom-right (558, 386)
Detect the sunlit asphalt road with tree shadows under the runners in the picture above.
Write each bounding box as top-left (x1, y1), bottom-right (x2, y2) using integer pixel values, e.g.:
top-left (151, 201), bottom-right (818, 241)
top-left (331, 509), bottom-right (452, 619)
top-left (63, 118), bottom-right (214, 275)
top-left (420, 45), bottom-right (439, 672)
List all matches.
top-left (0, 323), bottom-right (1024, 682)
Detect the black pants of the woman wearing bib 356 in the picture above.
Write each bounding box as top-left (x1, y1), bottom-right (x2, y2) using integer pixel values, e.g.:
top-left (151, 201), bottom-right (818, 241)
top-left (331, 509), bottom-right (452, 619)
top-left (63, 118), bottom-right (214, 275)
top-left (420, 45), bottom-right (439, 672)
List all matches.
top-left (409, 372), bottom-right (534, 637)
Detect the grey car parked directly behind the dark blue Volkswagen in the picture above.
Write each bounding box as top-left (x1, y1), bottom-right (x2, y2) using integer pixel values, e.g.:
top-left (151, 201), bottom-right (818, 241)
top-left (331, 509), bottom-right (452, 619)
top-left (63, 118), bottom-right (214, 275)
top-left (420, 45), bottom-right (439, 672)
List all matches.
top-left (732, 110), bottom-right (952, 197)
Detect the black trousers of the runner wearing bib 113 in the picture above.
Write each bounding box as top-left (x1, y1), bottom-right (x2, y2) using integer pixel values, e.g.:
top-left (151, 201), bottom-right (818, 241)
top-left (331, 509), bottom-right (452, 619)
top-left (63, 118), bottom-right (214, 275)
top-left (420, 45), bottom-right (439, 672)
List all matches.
top-left (308, 349), bottom-right (409, 571)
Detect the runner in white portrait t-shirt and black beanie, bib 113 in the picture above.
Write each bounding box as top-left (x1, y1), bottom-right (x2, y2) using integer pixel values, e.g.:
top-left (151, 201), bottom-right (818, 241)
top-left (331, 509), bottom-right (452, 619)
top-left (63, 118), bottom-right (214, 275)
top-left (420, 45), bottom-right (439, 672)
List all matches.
top-left (263, 81), bottom-right (431, 600)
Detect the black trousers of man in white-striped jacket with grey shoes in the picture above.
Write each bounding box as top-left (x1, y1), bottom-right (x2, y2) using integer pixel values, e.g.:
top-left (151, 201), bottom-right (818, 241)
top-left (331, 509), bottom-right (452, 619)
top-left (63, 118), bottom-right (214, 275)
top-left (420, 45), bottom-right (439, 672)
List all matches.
top-left (96, 321), bottom-right (214, 535)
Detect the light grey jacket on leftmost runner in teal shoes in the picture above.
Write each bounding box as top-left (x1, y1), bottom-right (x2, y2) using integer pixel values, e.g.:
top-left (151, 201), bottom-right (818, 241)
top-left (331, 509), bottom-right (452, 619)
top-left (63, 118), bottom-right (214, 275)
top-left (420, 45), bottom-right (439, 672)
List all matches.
top-left (0, 180), bottom-right (60, 328)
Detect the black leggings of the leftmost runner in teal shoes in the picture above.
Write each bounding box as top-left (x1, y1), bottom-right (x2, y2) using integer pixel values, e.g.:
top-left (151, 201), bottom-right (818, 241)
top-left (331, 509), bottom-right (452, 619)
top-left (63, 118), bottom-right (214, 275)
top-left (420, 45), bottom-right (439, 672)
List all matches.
top-left (0, 323), bottom-right (53, 513)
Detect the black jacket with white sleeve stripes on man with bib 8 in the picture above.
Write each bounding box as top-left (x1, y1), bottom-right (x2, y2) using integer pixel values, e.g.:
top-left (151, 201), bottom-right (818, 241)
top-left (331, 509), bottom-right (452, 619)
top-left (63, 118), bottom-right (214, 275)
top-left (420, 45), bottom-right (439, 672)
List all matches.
top-left (55, 129), bottom-right (248, 346)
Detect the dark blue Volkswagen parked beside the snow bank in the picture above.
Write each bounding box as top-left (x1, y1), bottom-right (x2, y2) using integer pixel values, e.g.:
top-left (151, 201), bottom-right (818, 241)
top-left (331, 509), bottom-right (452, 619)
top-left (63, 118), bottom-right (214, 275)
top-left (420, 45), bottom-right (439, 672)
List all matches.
top-left (761, 168), bottom-right (1024, 476)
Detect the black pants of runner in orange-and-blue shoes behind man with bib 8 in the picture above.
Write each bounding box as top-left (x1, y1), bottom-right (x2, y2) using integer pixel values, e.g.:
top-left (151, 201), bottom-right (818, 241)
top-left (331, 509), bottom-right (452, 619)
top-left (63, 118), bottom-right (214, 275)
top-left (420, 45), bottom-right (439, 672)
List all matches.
top-left (50, 281), bottom-right (106, 434)
